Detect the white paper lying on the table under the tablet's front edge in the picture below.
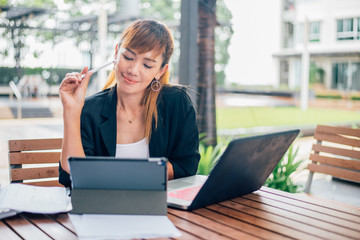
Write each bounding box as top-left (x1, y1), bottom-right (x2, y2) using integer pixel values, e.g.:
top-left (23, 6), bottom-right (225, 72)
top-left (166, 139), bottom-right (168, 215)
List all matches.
top-left (69, 214), bottom-right (181, 240)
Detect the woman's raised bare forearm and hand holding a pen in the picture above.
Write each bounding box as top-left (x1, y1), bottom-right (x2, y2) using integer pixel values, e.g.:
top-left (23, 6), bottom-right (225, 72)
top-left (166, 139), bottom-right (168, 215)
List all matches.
top-left (59, 67), bottom-right (92, 173)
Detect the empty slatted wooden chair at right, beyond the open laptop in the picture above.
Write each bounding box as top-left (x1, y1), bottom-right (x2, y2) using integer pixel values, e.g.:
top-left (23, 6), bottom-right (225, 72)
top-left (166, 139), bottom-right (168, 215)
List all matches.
top-left (304, 125), bottom-right (360, 193)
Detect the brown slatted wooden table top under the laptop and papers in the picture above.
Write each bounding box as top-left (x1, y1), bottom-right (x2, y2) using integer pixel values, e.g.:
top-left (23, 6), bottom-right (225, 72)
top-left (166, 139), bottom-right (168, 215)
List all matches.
top-left (0, 187), bottom-right (360, 240)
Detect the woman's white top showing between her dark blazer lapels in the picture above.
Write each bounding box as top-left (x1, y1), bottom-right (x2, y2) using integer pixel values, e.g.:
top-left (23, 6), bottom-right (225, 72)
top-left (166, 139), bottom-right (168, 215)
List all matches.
top-left (115, 138), bottom-right (150, 159)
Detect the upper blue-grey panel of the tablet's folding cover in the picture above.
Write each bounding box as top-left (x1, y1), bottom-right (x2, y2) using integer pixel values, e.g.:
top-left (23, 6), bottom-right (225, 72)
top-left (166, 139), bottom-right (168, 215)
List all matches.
top-left (69, 157), bottom-right (167, 191)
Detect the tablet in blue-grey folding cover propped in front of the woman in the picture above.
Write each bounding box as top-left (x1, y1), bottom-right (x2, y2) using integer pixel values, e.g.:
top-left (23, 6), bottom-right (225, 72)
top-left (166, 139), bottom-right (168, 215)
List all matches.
top-left (69, 157), bottom-right (167, 215)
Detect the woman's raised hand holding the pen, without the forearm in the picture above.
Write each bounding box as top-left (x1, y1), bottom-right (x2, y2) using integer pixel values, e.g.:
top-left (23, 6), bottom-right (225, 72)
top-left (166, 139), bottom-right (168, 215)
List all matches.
top-left (59, 67), bottom-right (92, 113)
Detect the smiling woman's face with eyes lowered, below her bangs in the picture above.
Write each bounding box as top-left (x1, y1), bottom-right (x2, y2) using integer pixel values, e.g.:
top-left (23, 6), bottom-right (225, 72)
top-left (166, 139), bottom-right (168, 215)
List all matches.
top-left (115, 48), bottom-right (168, 94)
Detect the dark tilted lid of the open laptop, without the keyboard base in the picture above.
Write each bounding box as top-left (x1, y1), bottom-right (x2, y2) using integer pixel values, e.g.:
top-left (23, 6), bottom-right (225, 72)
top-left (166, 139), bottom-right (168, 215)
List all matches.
top-left (189, 130), bottom-right (299, 209)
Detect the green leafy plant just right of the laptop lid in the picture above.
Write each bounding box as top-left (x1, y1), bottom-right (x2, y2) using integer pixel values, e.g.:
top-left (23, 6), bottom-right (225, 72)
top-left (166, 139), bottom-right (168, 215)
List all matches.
top-left (264, 145), bottom-right (304, 193)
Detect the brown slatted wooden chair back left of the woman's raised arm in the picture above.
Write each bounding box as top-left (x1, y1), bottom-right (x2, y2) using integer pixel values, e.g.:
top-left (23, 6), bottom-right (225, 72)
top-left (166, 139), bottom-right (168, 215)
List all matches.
top-left (9, 138), bottom-right (62, 186)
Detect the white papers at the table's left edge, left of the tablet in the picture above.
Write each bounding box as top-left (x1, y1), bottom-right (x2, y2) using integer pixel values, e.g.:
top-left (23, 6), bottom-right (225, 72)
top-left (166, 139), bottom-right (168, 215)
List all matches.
top-left (0, 183), bottom-right (71, 214)
